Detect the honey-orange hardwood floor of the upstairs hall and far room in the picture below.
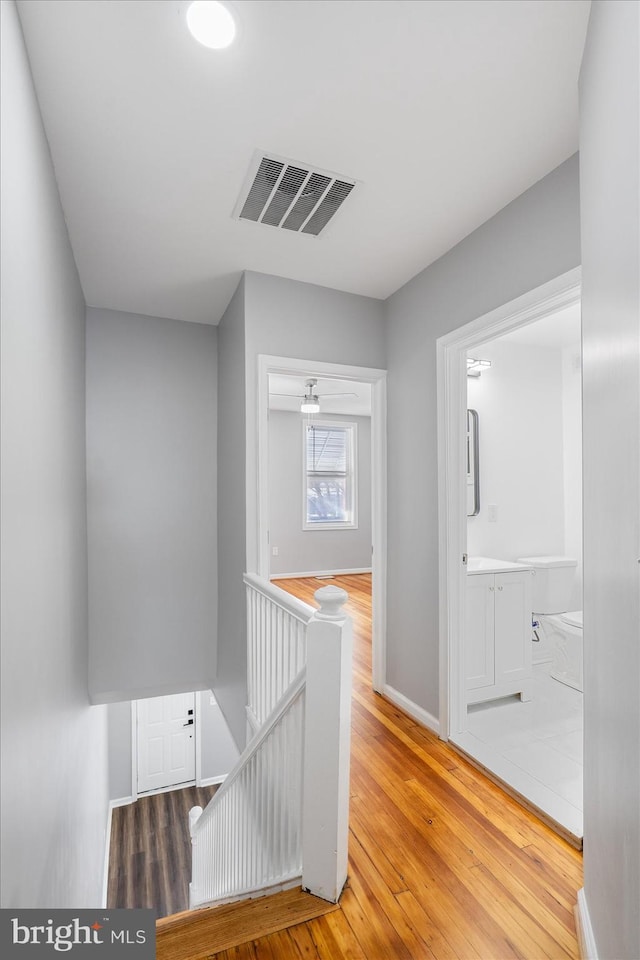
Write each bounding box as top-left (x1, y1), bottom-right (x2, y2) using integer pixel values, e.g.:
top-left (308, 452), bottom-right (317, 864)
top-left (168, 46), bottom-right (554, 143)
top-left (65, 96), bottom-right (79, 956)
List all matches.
top-left (209, 575), bottom-right (582, 960)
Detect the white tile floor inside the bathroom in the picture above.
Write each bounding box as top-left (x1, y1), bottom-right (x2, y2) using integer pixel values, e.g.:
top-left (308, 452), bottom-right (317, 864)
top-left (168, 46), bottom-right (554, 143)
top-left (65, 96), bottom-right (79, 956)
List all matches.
top-left (460, 664), bottom-right (582, 838)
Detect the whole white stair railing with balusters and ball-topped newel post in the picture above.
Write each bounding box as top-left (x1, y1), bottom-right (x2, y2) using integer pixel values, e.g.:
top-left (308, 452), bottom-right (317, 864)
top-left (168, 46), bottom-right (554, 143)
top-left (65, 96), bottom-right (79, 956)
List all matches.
top-left (185, 574), bottom-right (352, 916)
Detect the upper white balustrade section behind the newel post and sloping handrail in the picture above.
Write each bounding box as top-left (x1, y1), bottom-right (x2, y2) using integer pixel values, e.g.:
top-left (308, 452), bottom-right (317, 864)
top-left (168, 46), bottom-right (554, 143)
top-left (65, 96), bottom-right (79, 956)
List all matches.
top-left (244, 573), bottom-right (315, 734)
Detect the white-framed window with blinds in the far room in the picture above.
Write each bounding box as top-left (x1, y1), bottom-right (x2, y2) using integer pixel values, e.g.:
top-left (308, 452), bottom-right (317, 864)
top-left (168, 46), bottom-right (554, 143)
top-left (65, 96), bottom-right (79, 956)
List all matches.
top-left (303, 420), bottom-right (358, 530)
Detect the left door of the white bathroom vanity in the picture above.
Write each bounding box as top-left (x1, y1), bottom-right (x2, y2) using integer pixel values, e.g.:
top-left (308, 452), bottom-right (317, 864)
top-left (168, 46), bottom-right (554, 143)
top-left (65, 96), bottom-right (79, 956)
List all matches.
top-left (464, 573), bottom-right (495, 690)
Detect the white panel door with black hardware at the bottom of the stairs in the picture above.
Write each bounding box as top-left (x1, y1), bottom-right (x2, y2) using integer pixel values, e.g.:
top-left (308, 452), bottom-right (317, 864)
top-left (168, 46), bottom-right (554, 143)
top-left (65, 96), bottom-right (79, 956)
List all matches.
top-left (137, 693), bottom-right (196, 793)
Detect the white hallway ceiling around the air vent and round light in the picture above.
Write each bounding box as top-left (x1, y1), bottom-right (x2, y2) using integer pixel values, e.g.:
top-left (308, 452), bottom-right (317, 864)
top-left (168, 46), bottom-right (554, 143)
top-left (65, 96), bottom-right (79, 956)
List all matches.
top-left (18, 0), bottom-right (589, 324)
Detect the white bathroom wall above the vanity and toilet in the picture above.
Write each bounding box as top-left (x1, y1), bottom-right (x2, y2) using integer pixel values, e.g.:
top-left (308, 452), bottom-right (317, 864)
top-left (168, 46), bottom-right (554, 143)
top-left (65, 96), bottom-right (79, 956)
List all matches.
top-left (467, 340), bottom-right (564, 560)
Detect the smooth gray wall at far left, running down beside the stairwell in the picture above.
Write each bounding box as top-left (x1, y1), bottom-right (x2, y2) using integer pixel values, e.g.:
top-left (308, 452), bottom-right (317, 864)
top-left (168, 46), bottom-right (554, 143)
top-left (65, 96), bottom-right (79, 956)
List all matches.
top-left (0, 2), bottom-right (108, 908)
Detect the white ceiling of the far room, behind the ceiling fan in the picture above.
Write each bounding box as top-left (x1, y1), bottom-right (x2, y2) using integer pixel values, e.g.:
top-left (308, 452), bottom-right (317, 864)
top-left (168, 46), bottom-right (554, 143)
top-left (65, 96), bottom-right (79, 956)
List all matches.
top-left (269, 373), bottom-right (371, 419)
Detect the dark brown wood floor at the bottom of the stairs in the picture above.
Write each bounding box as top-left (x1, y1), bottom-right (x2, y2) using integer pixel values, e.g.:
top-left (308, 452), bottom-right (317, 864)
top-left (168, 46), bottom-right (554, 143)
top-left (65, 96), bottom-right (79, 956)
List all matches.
top-left (107, 786), bottom-right (218, 917)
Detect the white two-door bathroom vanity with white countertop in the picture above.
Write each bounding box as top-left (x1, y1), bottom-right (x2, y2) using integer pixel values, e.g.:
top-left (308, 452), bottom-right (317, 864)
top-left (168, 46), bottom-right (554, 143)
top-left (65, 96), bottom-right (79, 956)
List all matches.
top-left (465, 557), bottom-right (532, 704)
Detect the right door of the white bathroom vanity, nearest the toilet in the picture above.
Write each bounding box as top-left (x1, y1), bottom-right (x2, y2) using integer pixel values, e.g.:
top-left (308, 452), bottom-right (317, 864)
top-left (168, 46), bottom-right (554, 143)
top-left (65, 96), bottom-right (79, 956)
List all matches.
top-left (495, 571), bottom-right (531, 684)
